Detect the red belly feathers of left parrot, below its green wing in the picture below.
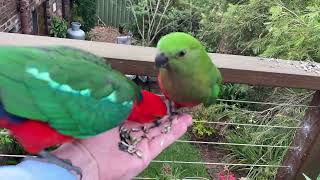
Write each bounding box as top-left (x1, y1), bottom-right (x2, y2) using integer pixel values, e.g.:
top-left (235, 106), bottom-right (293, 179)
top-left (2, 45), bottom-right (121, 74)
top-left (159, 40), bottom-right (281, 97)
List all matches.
top-left (0, 118), bottom-right (74, 154)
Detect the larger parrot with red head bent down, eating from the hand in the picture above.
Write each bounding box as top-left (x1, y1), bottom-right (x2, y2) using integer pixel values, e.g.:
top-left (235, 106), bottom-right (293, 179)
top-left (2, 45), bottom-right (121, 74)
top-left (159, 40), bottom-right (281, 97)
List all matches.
top-left (0, 46), bottom-right (167, 174)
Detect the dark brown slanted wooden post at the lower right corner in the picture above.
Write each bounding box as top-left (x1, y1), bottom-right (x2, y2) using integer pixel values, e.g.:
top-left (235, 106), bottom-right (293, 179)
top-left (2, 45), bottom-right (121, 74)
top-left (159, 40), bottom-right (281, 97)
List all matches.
top-left (276, 91), bottom-right (320, 180)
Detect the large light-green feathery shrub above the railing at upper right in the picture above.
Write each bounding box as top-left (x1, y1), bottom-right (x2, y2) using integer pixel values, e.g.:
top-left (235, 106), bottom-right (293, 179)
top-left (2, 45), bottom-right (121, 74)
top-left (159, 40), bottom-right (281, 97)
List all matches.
top-left (198, 0), bottom-right (320, 61)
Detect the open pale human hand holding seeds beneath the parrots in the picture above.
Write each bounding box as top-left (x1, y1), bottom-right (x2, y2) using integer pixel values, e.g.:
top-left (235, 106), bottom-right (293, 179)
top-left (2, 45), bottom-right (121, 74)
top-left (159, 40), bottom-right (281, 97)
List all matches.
top-left (54, 114), bottom-right (192, 180)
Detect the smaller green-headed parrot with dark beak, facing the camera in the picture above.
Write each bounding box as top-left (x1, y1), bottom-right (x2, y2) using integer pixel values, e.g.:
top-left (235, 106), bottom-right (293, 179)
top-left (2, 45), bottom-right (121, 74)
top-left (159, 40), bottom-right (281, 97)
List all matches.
top-left (155, 32), bottom-right (222, 129)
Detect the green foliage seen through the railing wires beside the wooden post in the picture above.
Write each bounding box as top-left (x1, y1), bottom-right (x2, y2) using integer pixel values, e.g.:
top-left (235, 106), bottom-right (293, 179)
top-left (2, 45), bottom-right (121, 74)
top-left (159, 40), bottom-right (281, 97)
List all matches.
top-left (193, 85), bottom-right (313, 179)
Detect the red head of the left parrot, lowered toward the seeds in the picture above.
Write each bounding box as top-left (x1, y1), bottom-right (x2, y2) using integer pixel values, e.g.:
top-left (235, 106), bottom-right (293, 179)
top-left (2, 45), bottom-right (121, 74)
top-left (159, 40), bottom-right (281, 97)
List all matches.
top-left (128, 90), bottom-right (167, 123)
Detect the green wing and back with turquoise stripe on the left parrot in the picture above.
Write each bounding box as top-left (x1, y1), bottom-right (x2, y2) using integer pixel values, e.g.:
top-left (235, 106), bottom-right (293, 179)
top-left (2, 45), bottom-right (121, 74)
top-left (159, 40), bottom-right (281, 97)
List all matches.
top-left (0, 47), bottom-right (141, 138)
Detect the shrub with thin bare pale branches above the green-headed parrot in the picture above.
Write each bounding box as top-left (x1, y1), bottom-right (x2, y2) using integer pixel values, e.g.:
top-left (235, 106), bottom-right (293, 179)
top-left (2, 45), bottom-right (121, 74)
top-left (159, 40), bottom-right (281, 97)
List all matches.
top-left (126, 0), bottom-right (201, 46)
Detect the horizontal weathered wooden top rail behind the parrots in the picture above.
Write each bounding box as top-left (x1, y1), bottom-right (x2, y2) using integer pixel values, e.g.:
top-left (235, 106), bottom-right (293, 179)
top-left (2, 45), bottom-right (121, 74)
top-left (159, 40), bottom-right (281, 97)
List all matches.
top-left (0, 33), bottom-right (320, 90)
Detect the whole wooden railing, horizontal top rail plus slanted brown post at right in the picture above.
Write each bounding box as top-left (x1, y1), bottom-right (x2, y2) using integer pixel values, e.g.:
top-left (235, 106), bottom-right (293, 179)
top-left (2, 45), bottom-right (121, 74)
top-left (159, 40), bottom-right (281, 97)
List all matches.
top-left (0, 33), bottom-right (320, 180)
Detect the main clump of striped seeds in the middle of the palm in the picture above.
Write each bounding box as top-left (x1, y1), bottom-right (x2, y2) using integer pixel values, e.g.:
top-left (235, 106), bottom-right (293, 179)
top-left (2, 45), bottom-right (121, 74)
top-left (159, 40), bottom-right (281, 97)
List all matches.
top-left (118, 126), bottom-right (145, 158)
